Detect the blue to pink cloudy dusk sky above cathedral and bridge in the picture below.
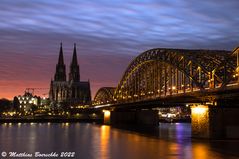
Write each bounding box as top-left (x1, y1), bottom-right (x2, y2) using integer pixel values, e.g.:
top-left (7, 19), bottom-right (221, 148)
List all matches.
top-left (0, 0), bottom-right (239, 99)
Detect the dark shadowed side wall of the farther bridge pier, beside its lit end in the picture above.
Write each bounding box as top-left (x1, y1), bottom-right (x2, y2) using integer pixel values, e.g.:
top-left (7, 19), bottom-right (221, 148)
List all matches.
top-left (110, 110), bottom-right (159, 126)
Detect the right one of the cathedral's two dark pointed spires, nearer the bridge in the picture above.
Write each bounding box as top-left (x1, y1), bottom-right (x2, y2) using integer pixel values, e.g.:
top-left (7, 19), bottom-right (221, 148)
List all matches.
top-left (69, 44), bottom-right (80, 82)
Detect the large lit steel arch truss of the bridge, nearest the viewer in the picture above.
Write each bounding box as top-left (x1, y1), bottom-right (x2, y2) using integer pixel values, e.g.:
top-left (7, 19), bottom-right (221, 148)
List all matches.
top-left (113, 48), bottom-right (237, 103)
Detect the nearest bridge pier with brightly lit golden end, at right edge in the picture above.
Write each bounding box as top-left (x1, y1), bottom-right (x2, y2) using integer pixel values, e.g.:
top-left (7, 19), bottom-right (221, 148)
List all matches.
top-left (191, 105), bottom-right (239, 139)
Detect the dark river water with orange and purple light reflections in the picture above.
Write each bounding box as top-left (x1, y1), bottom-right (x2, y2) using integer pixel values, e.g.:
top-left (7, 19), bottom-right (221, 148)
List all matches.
top-left (0, 123), bottom-right (239, 159)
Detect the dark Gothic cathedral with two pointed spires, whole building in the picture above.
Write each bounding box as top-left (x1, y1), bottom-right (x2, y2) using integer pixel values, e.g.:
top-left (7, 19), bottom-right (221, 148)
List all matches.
top-left (49, 44), bottom-right (91, 106)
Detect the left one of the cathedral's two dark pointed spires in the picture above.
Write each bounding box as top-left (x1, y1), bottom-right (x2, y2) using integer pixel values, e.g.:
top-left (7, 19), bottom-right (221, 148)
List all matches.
top-left (54, 43), bottom-right (66, 81)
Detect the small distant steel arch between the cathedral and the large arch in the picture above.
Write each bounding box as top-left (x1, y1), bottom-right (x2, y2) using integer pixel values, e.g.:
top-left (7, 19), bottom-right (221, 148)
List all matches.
top-left (93, 87), bottom-right (115, 105)
